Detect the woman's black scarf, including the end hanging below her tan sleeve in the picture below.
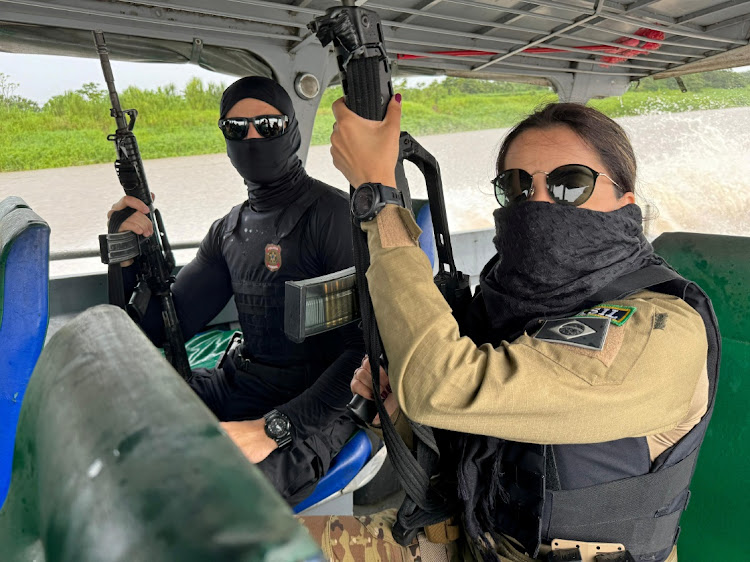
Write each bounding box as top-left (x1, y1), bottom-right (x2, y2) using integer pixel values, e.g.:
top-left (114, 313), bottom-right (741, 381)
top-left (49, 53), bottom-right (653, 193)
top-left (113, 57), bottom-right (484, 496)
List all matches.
top-left (462, 201), bottom-right (659, 560)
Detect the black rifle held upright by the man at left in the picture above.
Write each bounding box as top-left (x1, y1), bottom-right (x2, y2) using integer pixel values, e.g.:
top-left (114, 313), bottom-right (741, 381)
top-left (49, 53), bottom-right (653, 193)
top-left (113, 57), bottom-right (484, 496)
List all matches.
top-left (94, 31), bottom-right (192, 380)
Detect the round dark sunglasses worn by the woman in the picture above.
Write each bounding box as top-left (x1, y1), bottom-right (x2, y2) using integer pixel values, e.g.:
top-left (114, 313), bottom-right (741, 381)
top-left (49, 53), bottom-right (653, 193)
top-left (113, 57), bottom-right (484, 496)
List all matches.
top-left (492, 164), bottom-right (621, 207)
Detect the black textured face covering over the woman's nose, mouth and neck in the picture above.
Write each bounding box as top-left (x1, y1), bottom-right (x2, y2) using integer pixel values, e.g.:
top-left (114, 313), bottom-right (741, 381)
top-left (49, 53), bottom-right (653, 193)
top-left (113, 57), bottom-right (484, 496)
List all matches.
top-left (479, 201), bottom-right (657, 338)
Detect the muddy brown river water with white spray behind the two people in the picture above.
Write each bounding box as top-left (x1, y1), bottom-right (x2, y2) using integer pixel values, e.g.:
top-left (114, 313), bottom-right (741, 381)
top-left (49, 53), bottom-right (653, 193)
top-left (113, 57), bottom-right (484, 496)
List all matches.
top-left (0, 108), bottom-right (750, 276)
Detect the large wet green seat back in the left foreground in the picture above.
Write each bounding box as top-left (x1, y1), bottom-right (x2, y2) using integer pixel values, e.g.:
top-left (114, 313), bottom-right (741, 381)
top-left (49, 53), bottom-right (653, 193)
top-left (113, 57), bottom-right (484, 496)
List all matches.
top-left (0, 305), bottom-right (320, 562)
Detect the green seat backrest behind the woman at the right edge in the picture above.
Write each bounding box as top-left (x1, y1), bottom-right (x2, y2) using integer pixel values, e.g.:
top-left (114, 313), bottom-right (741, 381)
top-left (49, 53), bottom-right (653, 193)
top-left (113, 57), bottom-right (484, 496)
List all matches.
top-left (654, 232), bottom-right (750, 562)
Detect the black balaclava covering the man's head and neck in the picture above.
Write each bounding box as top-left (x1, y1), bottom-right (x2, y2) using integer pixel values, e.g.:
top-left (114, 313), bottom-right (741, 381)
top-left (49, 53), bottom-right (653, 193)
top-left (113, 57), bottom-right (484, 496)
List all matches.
top-left (220, 76), bottom-right (308, 211)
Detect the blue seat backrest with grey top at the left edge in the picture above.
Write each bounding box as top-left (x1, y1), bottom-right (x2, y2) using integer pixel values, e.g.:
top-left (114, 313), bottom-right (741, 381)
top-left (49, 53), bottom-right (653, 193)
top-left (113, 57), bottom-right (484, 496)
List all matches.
top-left (0, 197), bottom-right (49, 504)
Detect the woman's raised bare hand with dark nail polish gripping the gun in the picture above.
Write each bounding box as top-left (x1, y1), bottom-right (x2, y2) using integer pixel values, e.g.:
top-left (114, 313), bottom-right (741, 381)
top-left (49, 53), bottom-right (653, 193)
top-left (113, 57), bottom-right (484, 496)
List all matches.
top-left (331, 94), bottom-right (401, 187)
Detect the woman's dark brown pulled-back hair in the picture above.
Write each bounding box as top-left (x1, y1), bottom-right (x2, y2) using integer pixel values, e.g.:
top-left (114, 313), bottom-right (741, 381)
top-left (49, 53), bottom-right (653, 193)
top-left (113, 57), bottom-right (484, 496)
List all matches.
top-left (497, 103), bottom-right (636, 196)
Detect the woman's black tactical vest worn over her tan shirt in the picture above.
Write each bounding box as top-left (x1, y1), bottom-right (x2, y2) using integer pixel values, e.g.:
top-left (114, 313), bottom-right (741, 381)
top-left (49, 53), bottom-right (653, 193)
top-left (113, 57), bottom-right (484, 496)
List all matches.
top-left (470, 265), bottom-right (721, 562)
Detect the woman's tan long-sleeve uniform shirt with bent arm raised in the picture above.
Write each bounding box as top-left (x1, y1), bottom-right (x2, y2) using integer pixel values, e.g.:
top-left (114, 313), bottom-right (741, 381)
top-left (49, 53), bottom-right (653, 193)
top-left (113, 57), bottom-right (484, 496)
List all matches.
top-left (362, 205), bottom-right (708, 450)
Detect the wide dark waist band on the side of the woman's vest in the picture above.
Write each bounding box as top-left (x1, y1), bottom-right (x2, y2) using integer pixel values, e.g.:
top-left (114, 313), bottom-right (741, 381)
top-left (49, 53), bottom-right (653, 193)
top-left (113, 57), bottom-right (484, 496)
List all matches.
top-left (547, 444), bottom-right (698, 556)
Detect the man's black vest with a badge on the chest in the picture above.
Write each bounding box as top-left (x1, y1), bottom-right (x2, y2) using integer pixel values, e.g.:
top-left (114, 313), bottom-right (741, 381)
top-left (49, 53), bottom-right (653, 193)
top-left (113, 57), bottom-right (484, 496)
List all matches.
top-left (221, 179), bottom-right (326, 366)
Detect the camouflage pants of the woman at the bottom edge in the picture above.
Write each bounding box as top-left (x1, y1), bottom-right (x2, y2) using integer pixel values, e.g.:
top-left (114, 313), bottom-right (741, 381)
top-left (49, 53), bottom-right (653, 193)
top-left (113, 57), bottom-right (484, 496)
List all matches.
top-left (298, 509), bottom-right (465, 562)
